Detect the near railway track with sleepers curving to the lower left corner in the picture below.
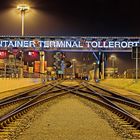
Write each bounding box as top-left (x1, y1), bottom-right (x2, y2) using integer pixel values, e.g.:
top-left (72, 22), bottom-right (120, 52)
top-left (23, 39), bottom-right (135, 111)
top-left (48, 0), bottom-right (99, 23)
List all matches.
top-left (0, 82), bottom-right (83, 138)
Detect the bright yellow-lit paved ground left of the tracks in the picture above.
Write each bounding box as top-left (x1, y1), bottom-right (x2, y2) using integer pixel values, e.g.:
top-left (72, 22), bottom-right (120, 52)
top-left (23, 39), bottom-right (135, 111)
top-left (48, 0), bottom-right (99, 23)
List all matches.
top-left (0, 78), bottom-right (41, 99)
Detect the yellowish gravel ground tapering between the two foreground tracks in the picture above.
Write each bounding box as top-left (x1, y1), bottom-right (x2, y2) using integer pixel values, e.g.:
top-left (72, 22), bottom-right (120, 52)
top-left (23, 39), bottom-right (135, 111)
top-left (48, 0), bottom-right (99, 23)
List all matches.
top-left (17, 97), bottom-right (121, 140)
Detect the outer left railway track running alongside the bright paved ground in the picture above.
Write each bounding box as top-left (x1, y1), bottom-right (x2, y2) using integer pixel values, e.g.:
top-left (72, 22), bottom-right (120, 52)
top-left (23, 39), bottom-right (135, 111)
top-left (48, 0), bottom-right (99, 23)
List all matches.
top-left (0, 83), bottom-right (60, 118)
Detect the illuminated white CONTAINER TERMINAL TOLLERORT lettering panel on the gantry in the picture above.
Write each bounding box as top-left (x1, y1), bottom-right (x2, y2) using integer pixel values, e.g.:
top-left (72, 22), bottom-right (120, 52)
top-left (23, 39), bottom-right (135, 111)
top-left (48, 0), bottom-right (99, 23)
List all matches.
top-left (0, 40), bottom-right (140, 49)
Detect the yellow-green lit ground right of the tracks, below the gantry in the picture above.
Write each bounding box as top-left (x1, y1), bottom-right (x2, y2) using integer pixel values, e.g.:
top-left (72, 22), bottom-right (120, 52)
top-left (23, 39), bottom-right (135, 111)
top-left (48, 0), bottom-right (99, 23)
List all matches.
top-left (90, 79), bottom-right (140, 101)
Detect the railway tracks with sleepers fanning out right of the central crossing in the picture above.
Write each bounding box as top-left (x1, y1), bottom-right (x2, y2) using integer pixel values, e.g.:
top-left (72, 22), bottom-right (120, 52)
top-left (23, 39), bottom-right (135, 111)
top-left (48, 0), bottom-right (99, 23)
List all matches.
top-left (66, 82), bottom-right (140, 139)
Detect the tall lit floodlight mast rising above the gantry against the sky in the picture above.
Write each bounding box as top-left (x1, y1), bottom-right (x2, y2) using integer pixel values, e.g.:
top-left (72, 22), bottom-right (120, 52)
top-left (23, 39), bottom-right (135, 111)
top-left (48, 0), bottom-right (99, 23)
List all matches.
top-left (17, 4), bottom-right (30, 36)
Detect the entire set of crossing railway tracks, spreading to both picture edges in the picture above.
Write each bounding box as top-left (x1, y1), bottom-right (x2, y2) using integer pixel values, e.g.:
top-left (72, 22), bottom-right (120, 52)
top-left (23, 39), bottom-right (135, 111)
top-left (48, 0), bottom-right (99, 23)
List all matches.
top-left (0, 81), bottom-right (140, 139)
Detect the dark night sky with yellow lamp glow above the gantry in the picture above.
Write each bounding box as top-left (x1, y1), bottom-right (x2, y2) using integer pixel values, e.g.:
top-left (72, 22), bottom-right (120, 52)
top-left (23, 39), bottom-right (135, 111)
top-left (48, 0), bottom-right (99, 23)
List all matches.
top-left (0, 0), bottom-right (140, 36)
